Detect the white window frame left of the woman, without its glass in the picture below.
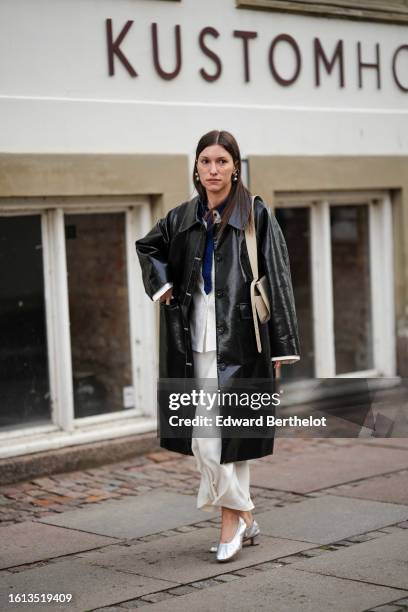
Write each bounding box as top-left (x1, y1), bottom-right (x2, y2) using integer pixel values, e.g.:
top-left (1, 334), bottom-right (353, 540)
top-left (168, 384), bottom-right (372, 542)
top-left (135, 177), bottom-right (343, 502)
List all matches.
top-left (0, 196), bottom-right (158, 458)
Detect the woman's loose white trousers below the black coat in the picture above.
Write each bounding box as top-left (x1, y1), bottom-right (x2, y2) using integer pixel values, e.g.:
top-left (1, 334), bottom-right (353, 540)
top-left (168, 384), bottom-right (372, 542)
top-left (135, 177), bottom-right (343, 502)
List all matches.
top-left (191, 351), bottom-right (255, 512)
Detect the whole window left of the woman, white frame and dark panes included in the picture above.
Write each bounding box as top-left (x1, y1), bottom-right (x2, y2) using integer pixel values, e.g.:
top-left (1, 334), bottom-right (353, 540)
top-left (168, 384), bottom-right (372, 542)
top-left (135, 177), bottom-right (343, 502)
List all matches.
top-left (0, 196), bottom-right (156, 438)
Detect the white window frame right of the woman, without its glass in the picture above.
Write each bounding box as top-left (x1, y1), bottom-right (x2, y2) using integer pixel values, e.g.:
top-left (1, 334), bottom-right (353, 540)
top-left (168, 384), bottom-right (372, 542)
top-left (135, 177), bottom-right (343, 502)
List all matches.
top-left (273, 190), bottom-right (396, 378)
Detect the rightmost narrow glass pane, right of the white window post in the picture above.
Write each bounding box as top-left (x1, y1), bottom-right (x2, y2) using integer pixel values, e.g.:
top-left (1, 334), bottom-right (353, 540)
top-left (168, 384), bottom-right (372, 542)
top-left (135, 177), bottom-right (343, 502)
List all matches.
top-left (330, 205), bottom-right (374, 374)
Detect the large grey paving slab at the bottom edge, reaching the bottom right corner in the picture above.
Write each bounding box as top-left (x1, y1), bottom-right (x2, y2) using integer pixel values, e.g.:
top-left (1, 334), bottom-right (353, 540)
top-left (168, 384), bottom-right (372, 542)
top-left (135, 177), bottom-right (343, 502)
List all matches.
top-left (148, 566), bottom-right (405, 612)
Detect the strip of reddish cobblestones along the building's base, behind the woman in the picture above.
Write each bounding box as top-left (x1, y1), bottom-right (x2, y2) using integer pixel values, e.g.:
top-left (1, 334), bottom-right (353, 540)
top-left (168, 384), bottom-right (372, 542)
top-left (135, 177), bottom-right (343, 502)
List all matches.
top-left (0, 438), bottom-right (355, 526)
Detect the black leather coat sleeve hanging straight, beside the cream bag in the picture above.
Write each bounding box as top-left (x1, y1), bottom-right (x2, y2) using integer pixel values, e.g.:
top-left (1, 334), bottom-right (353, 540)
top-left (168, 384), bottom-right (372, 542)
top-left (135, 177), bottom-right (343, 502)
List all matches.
top-left (260, 205), bottom-right (300, 363)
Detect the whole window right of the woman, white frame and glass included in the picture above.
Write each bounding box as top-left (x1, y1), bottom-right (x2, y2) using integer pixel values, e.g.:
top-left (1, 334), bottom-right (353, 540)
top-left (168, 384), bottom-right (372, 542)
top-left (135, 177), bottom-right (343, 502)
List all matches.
top-left (274, 192), bottom-right (396, 379)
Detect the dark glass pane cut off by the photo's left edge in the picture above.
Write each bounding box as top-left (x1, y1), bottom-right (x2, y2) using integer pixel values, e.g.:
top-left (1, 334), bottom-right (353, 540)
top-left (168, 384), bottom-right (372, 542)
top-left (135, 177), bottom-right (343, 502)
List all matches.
top-left (0, 215), bottom-right (51, 431)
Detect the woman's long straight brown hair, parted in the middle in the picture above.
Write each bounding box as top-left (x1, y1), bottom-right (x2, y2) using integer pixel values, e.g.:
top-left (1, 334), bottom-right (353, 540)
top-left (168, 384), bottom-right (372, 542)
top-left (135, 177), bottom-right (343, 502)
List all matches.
top-left (193, 130), bottom-right (251, 236)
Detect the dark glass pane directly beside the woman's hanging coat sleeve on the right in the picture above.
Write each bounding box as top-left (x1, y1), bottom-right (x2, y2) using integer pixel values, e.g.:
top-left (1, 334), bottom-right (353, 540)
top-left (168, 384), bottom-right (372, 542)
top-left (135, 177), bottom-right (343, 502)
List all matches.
top-left (275, 207), bottom-right (314, 380)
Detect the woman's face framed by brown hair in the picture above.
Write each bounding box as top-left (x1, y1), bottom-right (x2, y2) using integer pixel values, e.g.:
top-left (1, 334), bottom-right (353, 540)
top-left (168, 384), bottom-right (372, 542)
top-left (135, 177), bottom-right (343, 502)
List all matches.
top-left (197, 145), bottom-right (235, 195)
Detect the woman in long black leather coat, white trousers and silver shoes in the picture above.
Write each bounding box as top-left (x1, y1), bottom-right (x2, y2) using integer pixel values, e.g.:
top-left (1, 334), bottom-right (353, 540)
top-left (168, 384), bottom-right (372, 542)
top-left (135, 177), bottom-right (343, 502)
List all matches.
top-left (136, 130), bottom-right (300, 561)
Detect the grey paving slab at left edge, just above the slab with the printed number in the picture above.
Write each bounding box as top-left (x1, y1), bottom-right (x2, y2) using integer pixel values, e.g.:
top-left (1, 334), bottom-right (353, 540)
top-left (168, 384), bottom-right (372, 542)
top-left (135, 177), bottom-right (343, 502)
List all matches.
top-left (0, 521), bottom-right (117, 569)
